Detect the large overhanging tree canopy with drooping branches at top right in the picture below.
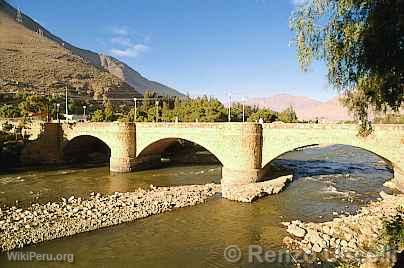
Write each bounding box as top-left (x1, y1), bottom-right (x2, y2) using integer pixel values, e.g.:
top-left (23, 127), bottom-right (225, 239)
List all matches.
top-left (290, 0), bottom-right (404, 133)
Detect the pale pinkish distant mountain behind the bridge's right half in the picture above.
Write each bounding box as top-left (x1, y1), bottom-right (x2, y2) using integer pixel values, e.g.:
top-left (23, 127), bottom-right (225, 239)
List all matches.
top-left (247, 94), bottom-right (352, 122)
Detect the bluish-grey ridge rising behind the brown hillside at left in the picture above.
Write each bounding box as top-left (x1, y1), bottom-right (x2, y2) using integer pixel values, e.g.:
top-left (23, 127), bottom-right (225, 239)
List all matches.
top-left (0, 0), bottom-right (184, 96)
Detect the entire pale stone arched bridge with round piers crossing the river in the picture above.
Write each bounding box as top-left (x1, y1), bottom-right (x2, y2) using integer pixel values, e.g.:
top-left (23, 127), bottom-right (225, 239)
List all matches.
top-left (25, 122), bottom-right (404, 190)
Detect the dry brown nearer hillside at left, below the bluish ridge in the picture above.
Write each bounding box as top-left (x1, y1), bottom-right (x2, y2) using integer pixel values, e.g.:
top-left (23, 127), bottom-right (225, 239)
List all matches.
top-left (0, 0), bottom-right (143, 99)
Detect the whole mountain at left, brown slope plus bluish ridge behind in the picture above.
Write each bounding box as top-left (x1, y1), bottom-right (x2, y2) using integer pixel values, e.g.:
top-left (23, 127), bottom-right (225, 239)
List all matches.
top-left (0, 0), bottom-right (183, 98)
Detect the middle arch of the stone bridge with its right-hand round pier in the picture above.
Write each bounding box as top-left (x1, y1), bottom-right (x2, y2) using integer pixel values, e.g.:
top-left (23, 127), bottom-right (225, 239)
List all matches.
top-left (136, 123), bottom-right (262, 184)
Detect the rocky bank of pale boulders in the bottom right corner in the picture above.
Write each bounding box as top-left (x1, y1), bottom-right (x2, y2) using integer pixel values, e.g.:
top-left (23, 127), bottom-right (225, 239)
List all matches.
top-left (283, 187), bottom-right (404, 267)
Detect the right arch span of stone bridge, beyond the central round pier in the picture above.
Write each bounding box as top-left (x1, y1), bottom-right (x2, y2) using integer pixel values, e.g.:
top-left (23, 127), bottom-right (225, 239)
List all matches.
top-left (262, 124), bottom-right (404, 189)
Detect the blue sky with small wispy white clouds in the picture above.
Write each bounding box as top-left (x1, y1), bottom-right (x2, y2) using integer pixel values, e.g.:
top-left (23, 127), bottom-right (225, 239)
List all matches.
top-left (9, 0), bottom-right (336, 100)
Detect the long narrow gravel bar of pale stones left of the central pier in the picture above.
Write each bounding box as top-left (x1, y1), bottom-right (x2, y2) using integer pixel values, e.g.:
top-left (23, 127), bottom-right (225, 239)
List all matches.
top-left (0, 184), bottom-right (220, 251)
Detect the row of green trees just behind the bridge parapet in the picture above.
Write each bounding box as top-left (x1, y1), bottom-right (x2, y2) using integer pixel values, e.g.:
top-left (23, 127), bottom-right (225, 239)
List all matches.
top-left (66, 92), bottom-right (297, 122)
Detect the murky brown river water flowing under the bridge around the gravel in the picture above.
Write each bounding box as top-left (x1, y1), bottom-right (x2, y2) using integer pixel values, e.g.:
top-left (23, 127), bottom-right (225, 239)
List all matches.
top-left (0, 145), bottom-right (392, 267)
